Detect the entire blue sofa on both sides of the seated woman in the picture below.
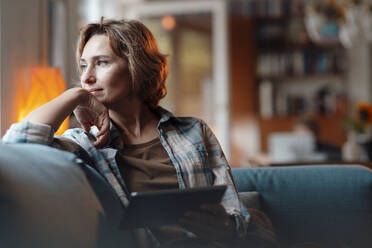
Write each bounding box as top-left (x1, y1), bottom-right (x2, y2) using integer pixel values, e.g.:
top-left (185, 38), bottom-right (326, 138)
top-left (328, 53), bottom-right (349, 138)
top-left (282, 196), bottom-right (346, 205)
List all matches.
top-left (0, 144), bottom-right (372, 248)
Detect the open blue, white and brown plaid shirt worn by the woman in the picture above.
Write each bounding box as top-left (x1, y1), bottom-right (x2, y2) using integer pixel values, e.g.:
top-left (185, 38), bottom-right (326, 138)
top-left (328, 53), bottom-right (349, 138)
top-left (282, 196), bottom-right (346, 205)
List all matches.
top-left (2, 107), bottom-right (276, 246)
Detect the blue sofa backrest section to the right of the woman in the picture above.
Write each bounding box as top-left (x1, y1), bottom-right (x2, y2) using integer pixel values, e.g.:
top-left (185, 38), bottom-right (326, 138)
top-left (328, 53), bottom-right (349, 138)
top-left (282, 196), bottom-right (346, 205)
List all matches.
top-left (232, 165), bottom-right (372, 248)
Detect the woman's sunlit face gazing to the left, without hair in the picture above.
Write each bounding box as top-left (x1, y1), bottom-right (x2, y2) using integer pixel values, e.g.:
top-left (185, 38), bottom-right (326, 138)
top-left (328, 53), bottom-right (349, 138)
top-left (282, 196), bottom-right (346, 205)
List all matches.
top-left (80, 34), bottom-right (132, 108)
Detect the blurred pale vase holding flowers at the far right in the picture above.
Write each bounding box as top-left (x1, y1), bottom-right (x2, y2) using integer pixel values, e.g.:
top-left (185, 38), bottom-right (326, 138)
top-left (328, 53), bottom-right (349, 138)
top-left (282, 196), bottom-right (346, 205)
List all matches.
top-left (342, 132), bottom-right (364, 161)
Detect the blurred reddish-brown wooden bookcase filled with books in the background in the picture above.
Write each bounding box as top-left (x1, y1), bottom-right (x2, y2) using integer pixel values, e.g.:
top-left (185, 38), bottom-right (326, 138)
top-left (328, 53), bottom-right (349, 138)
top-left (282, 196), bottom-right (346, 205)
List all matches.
top-left (230, 16), bottom-right (347, 157)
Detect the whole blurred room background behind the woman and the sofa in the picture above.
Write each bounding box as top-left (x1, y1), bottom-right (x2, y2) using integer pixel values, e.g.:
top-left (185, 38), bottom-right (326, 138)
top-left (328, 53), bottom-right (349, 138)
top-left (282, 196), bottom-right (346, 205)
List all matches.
top-left (0, 0), bottom-right (372, 167)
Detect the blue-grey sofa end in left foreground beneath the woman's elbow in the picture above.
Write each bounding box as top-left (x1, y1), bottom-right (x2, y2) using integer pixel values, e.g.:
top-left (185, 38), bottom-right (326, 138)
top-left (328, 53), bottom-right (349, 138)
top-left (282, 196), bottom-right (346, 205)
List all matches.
top-left (0, 144), bottom-right (132, 248)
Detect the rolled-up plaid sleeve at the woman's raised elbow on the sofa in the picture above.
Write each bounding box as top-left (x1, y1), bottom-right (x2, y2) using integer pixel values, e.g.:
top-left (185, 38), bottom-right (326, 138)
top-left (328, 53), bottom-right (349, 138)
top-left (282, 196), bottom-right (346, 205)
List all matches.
top-left (1, 121), bottom-right (54, 145)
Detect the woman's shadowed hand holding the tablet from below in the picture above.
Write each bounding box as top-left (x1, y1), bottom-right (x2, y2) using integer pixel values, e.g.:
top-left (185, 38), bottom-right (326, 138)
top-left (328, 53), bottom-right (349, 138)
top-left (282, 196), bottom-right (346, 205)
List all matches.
top-left (179, 204), bottom-right (235, 241)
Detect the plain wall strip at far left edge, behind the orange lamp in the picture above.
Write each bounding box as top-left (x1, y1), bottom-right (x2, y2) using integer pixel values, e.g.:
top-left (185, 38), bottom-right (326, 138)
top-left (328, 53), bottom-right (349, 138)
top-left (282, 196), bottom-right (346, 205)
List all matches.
top-left (0, 0), bottom-right (42, 135)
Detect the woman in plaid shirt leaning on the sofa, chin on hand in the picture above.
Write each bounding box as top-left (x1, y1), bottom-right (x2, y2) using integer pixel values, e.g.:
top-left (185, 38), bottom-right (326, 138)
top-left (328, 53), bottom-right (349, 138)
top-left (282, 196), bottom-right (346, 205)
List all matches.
top-left (3, 19), bottom-right (275, 247)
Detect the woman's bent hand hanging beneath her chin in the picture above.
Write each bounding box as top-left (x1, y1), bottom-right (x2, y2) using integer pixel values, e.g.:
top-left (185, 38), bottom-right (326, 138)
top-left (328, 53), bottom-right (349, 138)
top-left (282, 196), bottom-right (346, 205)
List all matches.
top-left (74, 93), bottom-right (110, 147)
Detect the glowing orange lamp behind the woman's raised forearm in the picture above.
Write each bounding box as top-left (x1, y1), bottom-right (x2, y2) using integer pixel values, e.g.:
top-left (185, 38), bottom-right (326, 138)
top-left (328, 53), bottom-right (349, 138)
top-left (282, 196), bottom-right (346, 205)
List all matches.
top-left (17, 67), bottom-right (68, 135)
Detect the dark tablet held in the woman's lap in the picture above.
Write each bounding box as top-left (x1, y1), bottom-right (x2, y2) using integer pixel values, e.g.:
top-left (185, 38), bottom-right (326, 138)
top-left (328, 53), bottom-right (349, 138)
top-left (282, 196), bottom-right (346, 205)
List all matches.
top-left (120, 185), bottom-right (226, 229)
